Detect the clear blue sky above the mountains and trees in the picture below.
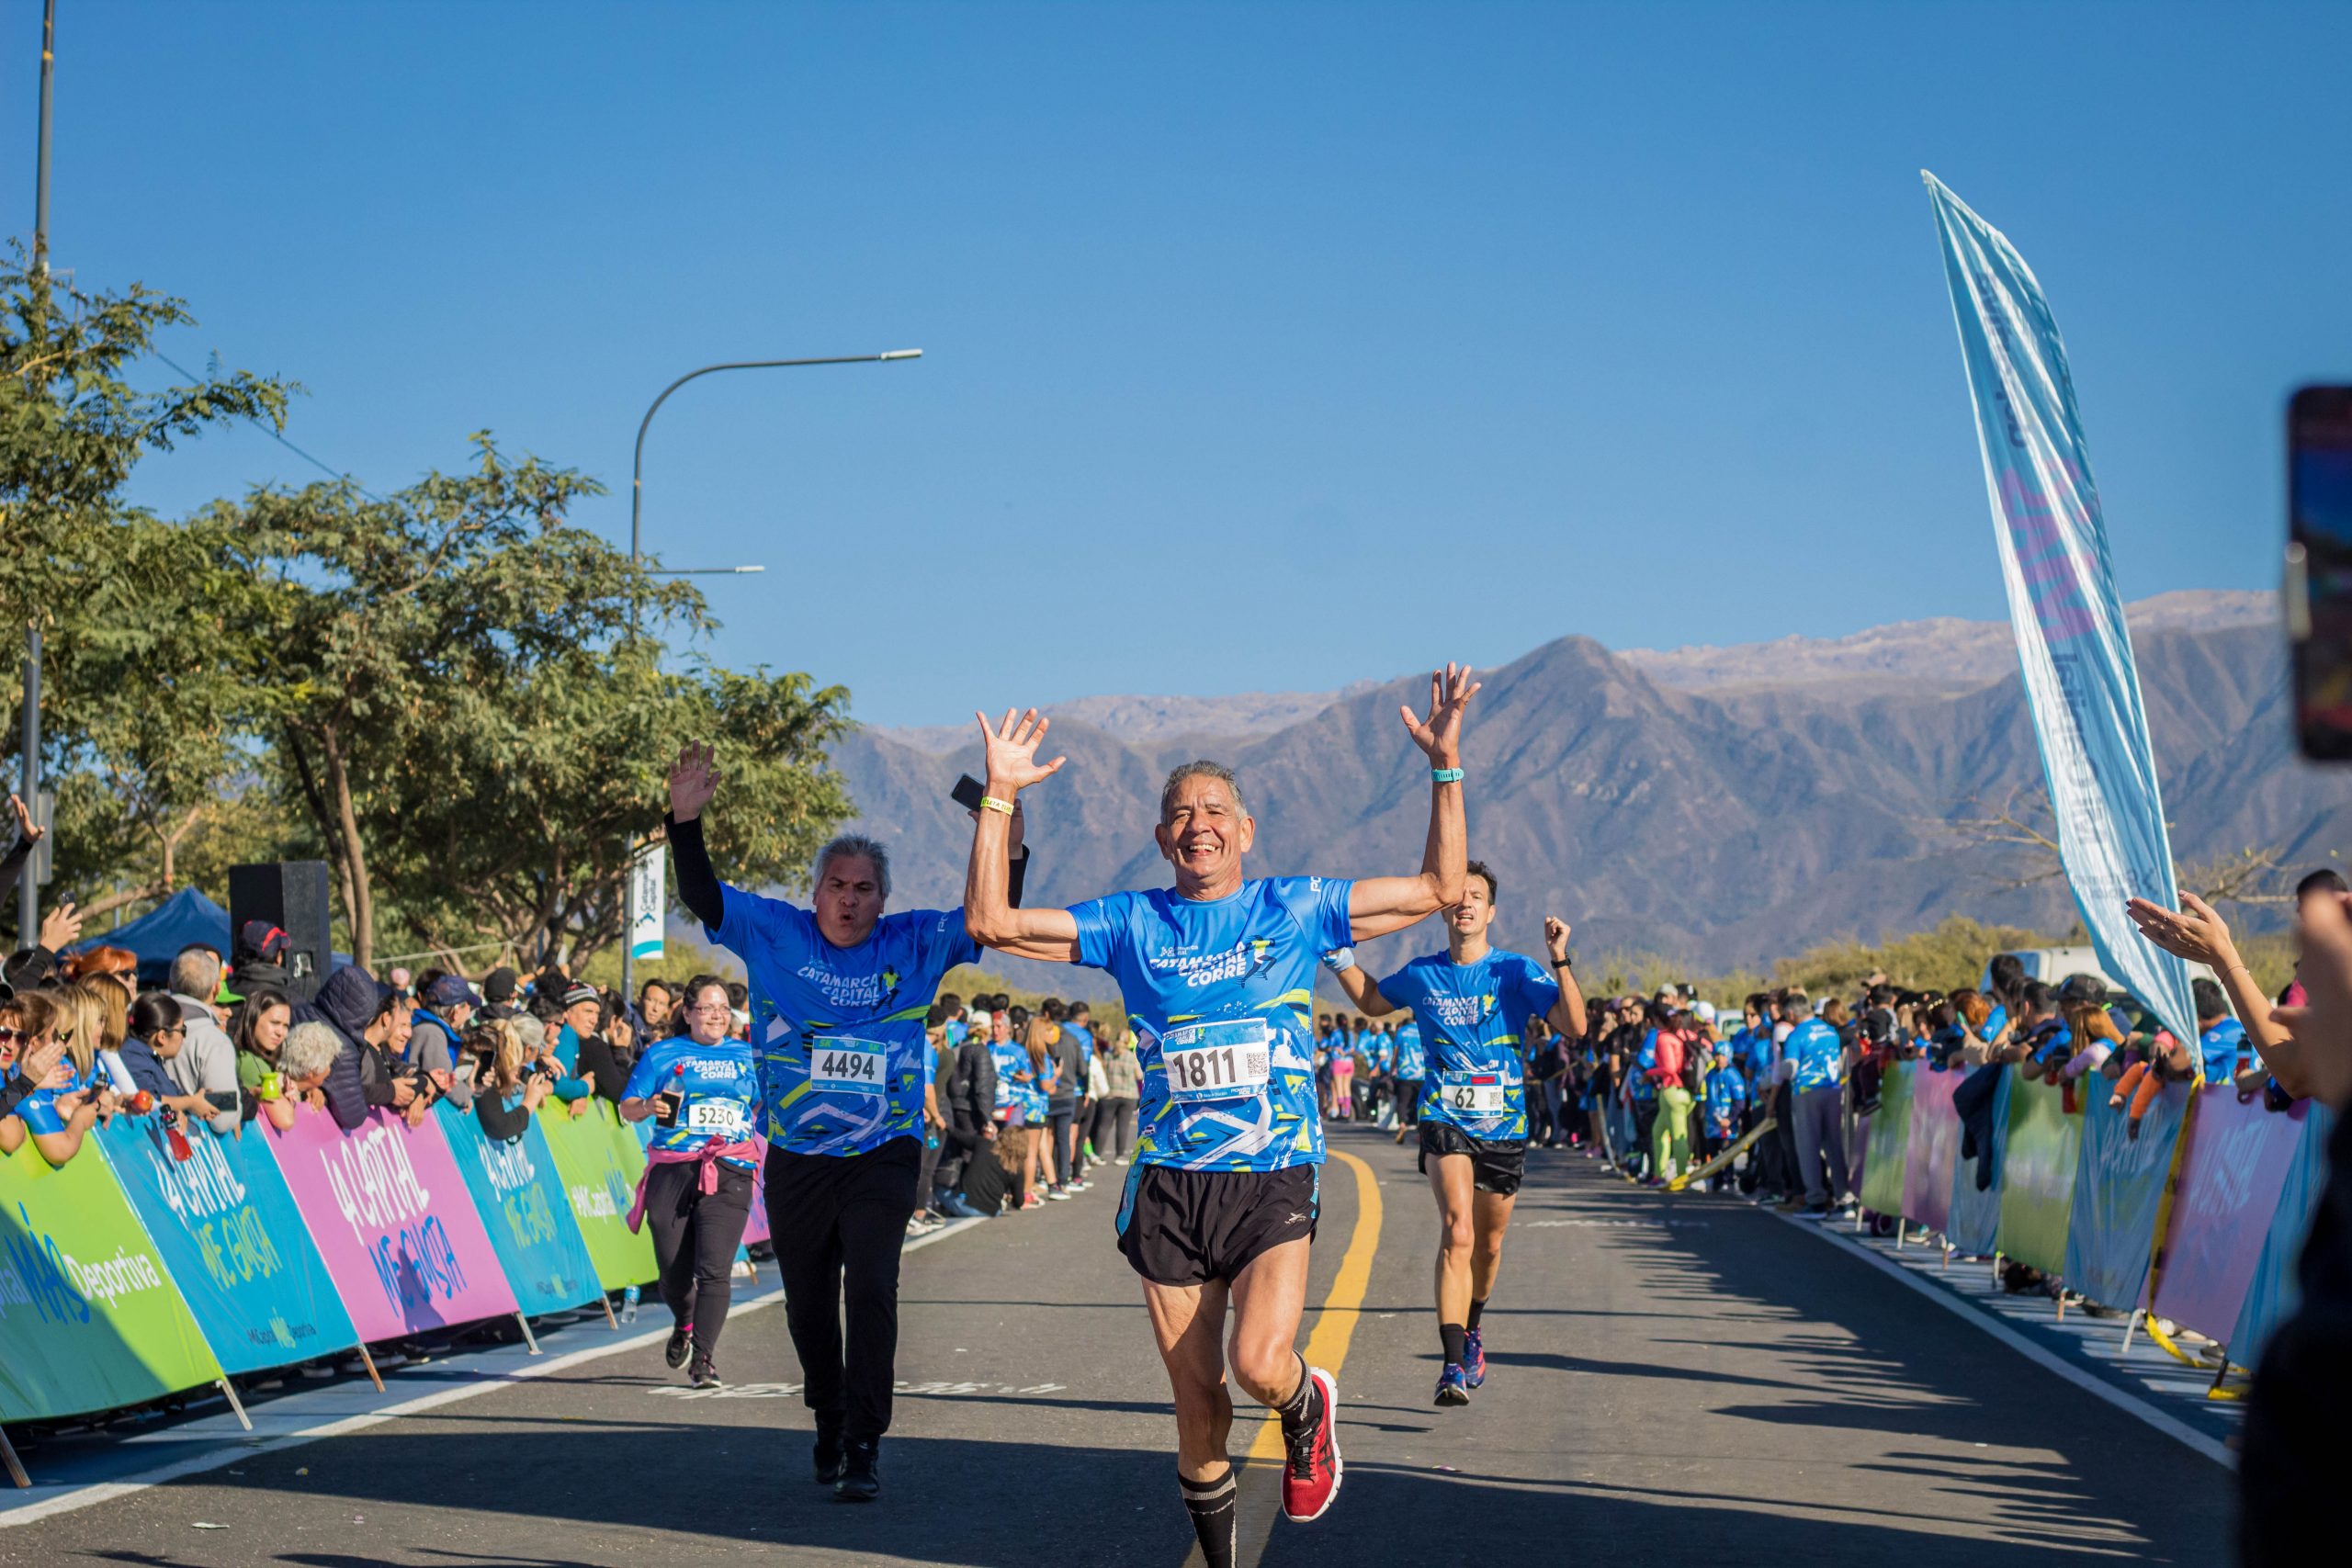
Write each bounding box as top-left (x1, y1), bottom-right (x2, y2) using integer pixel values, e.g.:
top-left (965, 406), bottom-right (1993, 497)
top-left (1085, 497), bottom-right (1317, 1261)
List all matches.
top-left (14, 0), bottom-right (2352, 724)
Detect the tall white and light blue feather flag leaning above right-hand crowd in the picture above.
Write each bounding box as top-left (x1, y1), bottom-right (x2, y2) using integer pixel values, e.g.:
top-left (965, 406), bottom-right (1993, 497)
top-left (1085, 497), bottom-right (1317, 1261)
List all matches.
top-left (1919, 169), bottom-right (2197, 1042)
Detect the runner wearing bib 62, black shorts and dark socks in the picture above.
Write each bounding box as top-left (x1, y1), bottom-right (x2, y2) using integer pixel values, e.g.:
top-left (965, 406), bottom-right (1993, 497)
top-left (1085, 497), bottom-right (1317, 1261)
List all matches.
top-left (1324, 861), bottom-right (1585, 1405)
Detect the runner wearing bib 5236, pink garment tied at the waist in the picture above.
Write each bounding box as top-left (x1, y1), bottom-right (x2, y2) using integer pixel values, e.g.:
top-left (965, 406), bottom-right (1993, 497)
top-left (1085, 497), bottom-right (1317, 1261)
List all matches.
top-left (621, 976), bottom-right (760, 1389)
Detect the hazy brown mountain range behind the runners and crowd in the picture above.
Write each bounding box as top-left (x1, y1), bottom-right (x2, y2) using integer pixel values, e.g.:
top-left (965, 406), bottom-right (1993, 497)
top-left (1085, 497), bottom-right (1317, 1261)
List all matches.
top-left (832, 592), bottom-right (2324, 992)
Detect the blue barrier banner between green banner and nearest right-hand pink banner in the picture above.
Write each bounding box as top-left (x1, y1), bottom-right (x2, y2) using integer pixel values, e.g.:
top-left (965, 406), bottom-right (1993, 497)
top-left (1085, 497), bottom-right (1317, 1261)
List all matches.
top-left (2063, 1075), bottom-right (2192, 1309)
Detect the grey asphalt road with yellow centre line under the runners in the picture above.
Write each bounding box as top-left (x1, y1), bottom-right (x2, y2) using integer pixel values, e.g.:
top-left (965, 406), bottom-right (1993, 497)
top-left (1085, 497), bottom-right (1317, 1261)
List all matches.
top-left (0, 1128), bottom-right (2234, 1568)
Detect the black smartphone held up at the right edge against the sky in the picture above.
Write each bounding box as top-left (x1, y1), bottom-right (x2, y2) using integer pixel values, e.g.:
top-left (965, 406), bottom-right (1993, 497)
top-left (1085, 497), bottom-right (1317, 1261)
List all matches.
top-left (2284, 386), bottom-right (2352, 761)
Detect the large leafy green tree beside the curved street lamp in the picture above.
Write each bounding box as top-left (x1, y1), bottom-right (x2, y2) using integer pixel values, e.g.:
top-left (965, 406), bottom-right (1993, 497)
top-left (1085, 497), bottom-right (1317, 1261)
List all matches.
top-left (217, 434), bottom-right (849, 964)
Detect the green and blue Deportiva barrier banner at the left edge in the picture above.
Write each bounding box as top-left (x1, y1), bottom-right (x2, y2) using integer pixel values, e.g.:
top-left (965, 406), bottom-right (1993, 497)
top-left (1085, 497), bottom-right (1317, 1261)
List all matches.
top-left (0, 1143), bottom-right (221, 1420)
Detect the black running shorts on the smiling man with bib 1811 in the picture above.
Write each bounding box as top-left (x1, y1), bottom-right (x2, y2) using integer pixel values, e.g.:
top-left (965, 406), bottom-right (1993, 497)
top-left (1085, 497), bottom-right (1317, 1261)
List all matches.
top-left (1120, 1166), bottom-right (1322, 1286)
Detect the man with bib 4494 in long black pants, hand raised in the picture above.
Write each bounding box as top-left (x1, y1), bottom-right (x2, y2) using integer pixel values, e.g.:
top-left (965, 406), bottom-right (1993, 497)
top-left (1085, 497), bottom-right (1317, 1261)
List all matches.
top-left (668, 745), bottom-right (1028, 1502)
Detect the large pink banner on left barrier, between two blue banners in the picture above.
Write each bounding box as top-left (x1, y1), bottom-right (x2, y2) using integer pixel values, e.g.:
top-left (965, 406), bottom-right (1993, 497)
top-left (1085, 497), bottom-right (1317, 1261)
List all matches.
top-left (256, 1110), bottom-right (515, 1340)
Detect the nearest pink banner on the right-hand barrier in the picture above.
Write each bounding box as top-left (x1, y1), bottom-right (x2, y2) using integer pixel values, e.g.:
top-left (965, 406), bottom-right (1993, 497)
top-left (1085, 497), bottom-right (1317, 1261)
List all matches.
top-left (2150, 1084), bottom-right (2302, 1340)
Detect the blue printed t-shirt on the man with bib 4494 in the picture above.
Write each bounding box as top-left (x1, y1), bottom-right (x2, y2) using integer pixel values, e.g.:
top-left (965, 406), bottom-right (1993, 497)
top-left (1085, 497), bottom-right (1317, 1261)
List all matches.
top-left (713, 886), bottom-right (981, 1155)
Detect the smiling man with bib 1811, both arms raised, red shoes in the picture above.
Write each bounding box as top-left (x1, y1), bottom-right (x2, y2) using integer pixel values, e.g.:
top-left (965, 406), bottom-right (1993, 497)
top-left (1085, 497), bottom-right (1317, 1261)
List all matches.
top-left (965, 665), bottom-right (1477, 1568)
